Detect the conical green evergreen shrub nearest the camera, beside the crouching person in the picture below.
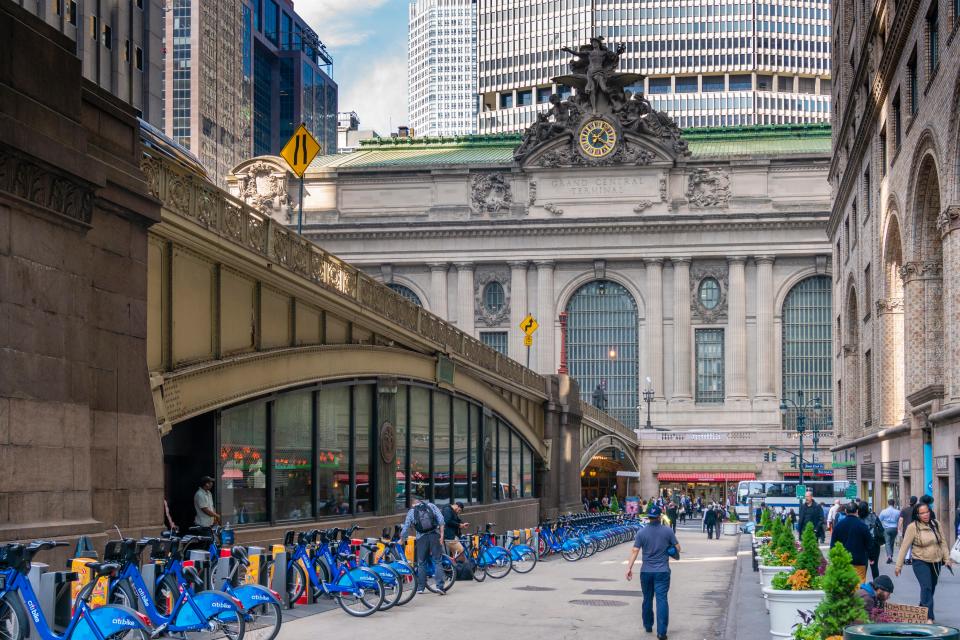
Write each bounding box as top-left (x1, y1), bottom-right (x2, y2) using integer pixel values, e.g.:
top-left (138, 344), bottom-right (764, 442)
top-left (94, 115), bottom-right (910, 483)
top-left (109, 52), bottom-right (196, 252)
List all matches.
top-left (788, 544), bottom-right (868, 640)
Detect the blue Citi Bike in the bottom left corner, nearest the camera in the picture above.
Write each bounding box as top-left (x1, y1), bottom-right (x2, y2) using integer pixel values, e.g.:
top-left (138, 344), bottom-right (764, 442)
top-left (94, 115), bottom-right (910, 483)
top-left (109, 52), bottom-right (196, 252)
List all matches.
top-left (0, 540), bottom-right (152, 640)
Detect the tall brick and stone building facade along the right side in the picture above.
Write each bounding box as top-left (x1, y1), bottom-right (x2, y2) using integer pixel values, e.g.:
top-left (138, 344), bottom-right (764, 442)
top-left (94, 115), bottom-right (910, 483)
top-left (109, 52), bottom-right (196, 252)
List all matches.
top-left (829, 0), bottom-right (960, 528)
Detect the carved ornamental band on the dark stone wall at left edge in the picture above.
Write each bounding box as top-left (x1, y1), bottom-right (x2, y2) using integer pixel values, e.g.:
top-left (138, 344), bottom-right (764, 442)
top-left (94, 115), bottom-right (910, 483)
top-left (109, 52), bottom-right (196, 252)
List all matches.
top-left (0, 149), bottom-right (93, 224)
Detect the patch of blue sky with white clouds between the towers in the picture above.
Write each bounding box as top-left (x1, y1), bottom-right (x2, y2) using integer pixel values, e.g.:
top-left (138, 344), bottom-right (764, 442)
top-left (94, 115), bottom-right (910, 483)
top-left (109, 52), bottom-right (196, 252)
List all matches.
top-left (294, 0), bottom-right (407, 135)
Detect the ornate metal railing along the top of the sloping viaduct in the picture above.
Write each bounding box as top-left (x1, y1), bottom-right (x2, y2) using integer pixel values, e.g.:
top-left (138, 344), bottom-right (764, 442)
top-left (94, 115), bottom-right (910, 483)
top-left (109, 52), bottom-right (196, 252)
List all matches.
top-left (140, 154), bottom-right (547, 395)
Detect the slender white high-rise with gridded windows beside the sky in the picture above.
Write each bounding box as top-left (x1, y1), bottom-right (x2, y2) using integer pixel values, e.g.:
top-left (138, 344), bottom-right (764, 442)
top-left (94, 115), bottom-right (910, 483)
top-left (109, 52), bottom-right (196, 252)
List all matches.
top-left (407, 0), bottom-right (477, 136)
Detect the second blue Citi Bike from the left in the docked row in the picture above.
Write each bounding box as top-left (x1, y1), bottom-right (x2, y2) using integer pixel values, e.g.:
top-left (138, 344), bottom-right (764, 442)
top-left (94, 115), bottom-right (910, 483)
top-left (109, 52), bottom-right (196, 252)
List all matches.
top-left (98, 538), bottom-right (246, 640)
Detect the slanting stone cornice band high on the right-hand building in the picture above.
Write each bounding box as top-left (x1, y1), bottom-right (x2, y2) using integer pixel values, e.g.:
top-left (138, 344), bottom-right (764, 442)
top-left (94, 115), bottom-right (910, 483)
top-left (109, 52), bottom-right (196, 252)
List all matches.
top-left (827, 0), bottom-right (920, 237)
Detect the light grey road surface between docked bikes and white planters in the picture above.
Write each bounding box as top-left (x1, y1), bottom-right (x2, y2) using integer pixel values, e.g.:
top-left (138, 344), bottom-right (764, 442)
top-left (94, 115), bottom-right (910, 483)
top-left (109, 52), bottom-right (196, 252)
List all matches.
top-left (279, 523), bottom-right (736, 640)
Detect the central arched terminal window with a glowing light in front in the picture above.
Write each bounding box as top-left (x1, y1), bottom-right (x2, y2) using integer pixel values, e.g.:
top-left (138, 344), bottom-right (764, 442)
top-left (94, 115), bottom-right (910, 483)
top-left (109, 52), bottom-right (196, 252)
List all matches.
top-left (566, 280), bottom-right (639, 428)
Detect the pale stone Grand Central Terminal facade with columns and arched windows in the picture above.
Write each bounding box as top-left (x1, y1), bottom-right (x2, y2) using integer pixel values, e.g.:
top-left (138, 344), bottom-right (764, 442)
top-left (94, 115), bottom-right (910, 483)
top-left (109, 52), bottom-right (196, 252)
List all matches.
top-left (228, 125), bottom-right (832, 495)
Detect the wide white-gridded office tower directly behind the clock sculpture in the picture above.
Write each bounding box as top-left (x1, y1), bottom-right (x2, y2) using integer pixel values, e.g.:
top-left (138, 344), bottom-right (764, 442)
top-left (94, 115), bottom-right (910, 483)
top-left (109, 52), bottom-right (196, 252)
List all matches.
top-left (478, 0), bottom-right (831, 133)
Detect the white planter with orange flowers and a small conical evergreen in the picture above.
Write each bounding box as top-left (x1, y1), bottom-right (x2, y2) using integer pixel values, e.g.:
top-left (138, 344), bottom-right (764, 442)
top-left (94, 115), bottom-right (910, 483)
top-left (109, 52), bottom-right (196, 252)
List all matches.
top-left (763, 523), bottom-right (825, 638)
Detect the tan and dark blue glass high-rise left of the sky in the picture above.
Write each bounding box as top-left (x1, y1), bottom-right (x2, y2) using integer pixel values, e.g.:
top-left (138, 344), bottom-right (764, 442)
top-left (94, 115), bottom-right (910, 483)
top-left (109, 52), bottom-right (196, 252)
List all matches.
top-left (165, 0), bottom-right (337, 185)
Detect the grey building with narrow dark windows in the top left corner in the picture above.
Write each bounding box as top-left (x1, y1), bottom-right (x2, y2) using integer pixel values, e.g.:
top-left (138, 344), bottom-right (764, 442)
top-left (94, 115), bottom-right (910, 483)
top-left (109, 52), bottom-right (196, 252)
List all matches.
top-left (19, 0), bottom-right (164, 127)
